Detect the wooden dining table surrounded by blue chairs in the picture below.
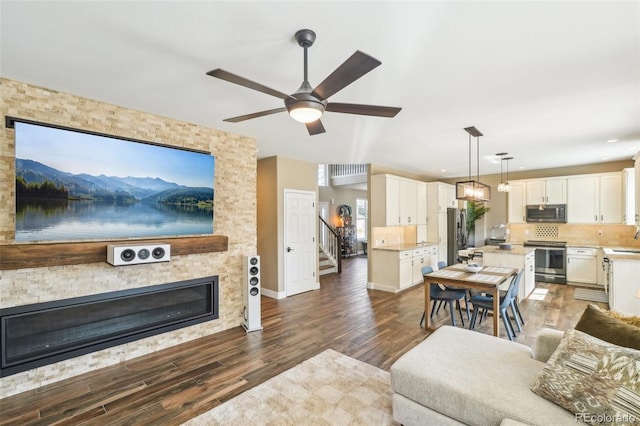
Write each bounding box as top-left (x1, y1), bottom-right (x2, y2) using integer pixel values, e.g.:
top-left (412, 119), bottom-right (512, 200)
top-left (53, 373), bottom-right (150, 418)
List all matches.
top-left (424, 263), bottom-right (518, 336)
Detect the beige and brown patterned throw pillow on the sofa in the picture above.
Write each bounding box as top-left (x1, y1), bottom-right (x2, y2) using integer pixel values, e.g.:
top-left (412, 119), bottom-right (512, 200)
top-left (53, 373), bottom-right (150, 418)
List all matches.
top-left (531, 330), bottom-right (640, 425)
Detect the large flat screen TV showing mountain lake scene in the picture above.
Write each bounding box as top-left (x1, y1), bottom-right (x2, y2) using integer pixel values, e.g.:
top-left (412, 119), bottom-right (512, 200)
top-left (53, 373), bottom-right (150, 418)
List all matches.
top-left (6, 117), bottom-right (215, 242)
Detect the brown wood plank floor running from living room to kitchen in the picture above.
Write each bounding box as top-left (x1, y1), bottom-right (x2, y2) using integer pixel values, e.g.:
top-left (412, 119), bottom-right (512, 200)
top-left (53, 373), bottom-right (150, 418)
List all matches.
top-left (0, 257), bottom-right (606, 426)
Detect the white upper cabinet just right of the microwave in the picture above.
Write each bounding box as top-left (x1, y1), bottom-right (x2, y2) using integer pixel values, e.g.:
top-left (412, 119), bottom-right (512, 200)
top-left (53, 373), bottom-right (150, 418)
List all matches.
top-left (567, 173), bottom-right (622, 224)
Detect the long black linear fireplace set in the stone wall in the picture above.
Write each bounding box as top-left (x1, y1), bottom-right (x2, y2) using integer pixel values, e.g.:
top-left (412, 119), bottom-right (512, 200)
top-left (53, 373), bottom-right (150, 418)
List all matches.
top-left (0, 276), bottom-right (219, 377)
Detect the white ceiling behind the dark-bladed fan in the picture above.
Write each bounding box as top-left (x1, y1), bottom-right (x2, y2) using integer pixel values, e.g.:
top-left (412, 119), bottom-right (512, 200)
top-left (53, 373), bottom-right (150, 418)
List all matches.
top-left (0, 0), bottom-right (640, 178)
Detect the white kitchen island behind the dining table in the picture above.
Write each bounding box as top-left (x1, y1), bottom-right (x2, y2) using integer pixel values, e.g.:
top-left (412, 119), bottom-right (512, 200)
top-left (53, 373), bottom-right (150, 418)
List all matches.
top-left (473, 244), bottom-right (536, 300)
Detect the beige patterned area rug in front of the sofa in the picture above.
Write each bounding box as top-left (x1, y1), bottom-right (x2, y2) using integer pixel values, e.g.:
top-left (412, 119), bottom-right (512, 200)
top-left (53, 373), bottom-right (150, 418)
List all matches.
top-left (185, 349), bottom-right (398, 426)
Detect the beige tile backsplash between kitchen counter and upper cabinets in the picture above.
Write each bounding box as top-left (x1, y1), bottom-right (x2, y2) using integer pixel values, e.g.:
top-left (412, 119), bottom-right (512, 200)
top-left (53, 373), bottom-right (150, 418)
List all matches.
top-left (507, 223), bottom-right (640, 248)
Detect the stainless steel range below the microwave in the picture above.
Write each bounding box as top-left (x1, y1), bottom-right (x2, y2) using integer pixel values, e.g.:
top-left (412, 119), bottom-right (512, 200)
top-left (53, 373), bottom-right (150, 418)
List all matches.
top-left (524, 240), bottom-right (567, 284)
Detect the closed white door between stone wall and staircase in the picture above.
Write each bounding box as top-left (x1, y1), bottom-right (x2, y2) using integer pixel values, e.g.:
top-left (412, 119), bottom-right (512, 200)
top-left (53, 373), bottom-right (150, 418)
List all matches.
top-left (284, 189), bottom-right (319, 296)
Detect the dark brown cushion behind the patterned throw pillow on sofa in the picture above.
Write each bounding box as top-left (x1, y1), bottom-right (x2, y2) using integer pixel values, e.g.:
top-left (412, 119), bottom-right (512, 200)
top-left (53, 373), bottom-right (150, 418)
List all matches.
top-left (575, 305), bottom-right (640, 349)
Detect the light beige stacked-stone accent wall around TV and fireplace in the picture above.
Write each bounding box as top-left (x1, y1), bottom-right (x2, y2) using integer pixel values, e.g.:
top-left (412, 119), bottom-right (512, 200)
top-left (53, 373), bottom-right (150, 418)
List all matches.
top-left (0, 79), bottom-right (257, 397)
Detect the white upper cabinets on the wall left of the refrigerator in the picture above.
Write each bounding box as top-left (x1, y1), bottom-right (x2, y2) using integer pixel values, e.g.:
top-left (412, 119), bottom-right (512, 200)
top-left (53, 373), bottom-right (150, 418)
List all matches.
top-left (370, 174), bottom-right (427, 226)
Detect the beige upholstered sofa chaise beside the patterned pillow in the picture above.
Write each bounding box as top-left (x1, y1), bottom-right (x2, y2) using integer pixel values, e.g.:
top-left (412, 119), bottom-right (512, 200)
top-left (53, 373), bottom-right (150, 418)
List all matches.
top-left (391, 326), bottom-right (576, 426)
